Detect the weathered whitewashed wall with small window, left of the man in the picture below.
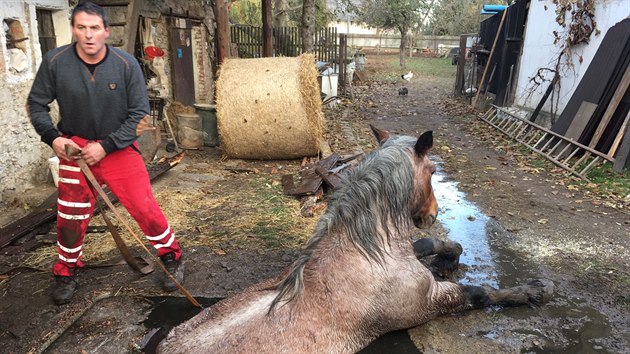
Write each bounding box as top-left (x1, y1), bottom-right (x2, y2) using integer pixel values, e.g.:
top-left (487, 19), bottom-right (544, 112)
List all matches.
top-left (0, 0), bottom-right (71, 203)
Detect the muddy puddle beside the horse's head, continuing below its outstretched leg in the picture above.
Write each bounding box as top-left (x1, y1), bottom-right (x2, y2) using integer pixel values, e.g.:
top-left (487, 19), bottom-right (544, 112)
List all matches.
top-left (433, 167), bottom-right (612, 353)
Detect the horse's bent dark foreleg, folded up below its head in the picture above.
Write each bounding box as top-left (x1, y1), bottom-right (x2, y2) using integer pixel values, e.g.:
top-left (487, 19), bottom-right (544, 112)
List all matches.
top-left (413, 238), bottom-right (463, 277)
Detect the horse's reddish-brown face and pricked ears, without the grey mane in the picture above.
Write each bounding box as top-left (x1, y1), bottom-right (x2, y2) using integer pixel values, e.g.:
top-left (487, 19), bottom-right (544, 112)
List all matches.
top-left (370, 125), bottom-right (438, 228)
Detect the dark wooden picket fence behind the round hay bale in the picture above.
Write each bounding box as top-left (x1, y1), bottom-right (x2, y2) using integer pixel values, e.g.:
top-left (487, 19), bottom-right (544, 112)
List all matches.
top-left (230, 25), bottom-right (339, 63)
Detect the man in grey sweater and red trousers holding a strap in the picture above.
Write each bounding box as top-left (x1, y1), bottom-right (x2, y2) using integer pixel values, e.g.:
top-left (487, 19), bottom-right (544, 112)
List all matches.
top-left (28, 2), bottom-right (184, 305)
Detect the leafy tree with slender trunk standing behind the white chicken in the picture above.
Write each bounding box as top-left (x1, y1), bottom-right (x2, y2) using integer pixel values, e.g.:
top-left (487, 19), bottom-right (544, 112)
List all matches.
top-left (349, 0), bottom-right (427, 67)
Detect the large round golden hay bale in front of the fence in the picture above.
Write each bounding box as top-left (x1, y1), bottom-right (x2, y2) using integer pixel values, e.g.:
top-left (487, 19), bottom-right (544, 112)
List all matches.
top-left (216, 54), bottom-right (323, 159)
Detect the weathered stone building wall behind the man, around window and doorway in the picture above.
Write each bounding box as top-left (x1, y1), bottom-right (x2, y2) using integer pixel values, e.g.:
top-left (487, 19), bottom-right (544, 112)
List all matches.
top-left (0, 0), bottom-right (214, 204)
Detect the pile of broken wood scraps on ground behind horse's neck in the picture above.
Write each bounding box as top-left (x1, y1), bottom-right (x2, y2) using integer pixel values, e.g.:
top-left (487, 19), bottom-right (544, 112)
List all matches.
top-left (282, 153), bottom-right (363, 216)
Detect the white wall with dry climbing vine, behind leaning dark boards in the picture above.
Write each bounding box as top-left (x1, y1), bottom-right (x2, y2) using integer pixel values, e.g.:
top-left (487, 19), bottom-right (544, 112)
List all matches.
top-left (515, 0), bottom-right (630, 114)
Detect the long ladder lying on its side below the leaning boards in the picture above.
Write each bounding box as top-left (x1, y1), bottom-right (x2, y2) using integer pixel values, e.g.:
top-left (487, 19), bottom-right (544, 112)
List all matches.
top-left (479, 105), bottom-right (614, 181)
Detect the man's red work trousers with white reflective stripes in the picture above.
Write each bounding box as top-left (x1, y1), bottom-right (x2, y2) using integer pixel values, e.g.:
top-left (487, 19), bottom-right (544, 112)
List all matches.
top-left (53, 137), bottom-right (181, 276)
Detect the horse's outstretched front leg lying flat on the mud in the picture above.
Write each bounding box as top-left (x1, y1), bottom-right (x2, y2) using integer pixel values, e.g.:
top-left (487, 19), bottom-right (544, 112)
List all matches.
top-left (432, 279), bottom-right (553, 314)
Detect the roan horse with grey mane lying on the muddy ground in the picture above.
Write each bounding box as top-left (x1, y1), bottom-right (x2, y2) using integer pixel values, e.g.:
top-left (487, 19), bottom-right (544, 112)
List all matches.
top-left (157, 126), bottom-right (553, 353)
